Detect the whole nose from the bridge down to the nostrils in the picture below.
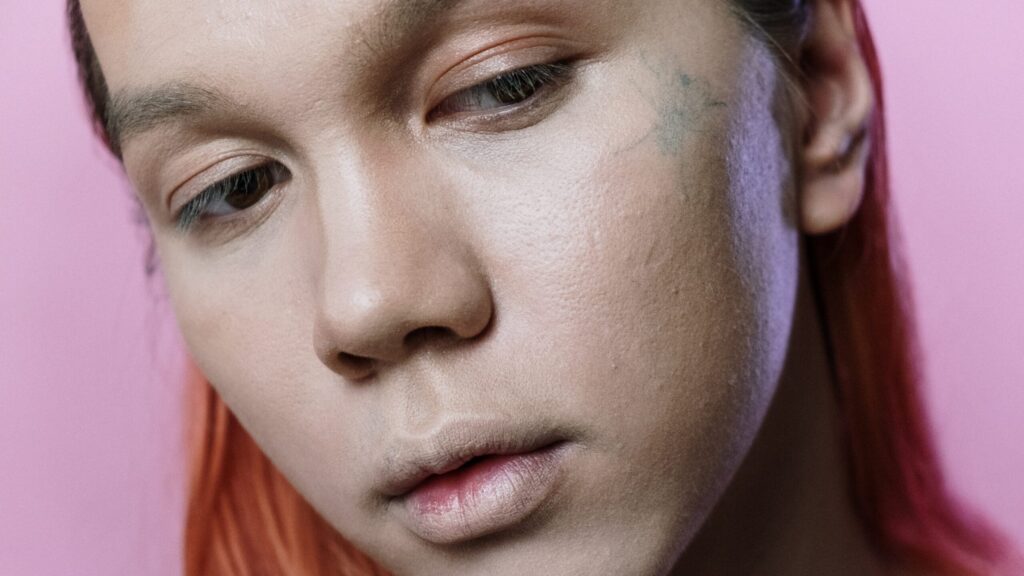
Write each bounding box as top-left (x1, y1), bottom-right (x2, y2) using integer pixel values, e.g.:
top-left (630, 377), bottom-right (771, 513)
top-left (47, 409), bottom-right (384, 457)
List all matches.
top-left (304, 145), bottom-right (494, 380)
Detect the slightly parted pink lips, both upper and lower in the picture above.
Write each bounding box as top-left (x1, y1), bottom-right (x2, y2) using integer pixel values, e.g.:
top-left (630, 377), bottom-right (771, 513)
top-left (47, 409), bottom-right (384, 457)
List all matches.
top-left (378, 420), bottom-right (573, 544)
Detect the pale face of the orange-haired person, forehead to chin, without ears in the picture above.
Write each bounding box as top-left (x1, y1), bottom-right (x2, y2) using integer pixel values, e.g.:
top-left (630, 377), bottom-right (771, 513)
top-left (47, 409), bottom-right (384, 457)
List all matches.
top-left (84, 0), bottom-right (799, 575)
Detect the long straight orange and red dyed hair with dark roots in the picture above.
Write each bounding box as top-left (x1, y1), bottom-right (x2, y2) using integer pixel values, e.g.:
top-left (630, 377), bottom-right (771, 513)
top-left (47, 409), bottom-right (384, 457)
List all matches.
top-left (68, 0), bottom-right (1015, 576)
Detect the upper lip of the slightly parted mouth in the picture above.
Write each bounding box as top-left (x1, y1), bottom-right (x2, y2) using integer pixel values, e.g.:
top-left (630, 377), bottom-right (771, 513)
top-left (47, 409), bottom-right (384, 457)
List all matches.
top-left (377, 418), bottom-right (565, 497)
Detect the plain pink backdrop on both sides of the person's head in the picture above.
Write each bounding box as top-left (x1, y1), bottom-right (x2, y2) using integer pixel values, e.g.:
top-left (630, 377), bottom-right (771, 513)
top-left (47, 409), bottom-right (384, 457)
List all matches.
top-left (0, 0), bottom-right (1024, 576)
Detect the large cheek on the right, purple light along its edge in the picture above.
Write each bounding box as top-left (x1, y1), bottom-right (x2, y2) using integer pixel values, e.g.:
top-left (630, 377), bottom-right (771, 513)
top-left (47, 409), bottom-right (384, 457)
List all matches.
top-left (471, 36), bottom-right (799, 553)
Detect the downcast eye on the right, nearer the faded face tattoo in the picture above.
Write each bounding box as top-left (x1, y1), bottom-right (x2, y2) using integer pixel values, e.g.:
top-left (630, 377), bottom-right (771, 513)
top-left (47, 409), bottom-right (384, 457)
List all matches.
top-left (428, 61), bottom-right (572, 120)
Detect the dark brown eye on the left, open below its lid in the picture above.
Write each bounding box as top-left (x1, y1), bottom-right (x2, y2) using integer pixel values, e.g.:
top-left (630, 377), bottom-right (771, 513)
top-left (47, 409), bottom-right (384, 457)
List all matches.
top-left (177, 162), bottom-right (291, 232)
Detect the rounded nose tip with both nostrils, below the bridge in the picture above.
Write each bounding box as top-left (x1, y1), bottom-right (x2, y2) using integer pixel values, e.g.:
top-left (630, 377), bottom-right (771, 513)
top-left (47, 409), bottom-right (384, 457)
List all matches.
top-left (315, 269), bottom-right (494, 381)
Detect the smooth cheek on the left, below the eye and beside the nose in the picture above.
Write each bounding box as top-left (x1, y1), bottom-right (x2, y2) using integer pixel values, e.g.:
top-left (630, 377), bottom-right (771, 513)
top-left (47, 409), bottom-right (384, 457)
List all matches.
top-left (161, 231), bottom-right (335, 455)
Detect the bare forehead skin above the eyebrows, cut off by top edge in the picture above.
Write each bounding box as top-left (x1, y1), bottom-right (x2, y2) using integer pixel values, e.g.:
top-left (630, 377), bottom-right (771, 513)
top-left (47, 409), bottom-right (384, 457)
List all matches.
top-left (82, 0), bottom-right (606, 90)
